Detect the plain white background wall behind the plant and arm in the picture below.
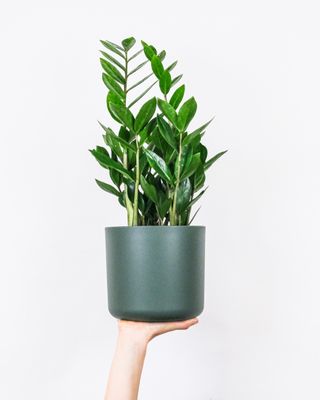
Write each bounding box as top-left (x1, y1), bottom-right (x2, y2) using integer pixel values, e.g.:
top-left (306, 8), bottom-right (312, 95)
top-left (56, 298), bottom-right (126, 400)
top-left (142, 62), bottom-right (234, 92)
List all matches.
top-left (0, 0), bottom-right (320, 400)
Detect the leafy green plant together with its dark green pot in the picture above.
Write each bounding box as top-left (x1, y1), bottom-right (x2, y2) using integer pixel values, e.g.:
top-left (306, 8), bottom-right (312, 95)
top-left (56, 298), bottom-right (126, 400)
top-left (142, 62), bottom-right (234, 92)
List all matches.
top-left (90, 37), bottom-right (225, 321)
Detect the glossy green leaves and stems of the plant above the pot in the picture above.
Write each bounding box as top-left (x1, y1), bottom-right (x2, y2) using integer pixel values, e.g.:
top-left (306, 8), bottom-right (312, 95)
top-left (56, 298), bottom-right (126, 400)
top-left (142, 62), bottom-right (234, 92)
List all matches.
top-left (90, 37), bottom-right (226, 226)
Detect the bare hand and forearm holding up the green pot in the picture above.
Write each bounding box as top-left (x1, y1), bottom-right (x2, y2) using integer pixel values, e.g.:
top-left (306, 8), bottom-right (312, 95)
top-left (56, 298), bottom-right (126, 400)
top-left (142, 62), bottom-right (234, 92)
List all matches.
top-left (104, 318), bottom-right (198, 400)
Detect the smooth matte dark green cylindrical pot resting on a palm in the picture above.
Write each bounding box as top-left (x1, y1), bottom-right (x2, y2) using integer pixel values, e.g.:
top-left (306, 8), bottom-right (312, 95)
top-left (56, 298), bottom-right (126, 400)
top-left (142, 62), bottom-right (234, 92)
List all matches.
top-left (106, 226), bottom-right (205, 321)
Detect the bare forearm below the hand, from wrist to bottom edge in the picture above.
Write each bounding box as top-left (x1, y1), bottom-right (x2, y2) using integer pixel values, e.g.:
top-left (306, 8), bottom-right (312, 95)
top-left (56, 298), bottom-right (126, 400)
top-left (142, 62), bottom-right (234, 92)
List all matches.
top-left (105, 332), bottom-right (147, 400)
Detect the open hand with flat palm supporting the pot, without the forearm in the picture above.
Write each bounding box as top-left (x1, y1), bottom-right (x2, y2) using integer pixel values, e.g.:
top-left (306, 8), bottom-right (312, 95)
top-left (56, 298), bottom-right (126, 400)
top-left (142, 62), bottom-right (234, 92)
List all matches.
top-left (118, 318), bottom-right (199, 344)
